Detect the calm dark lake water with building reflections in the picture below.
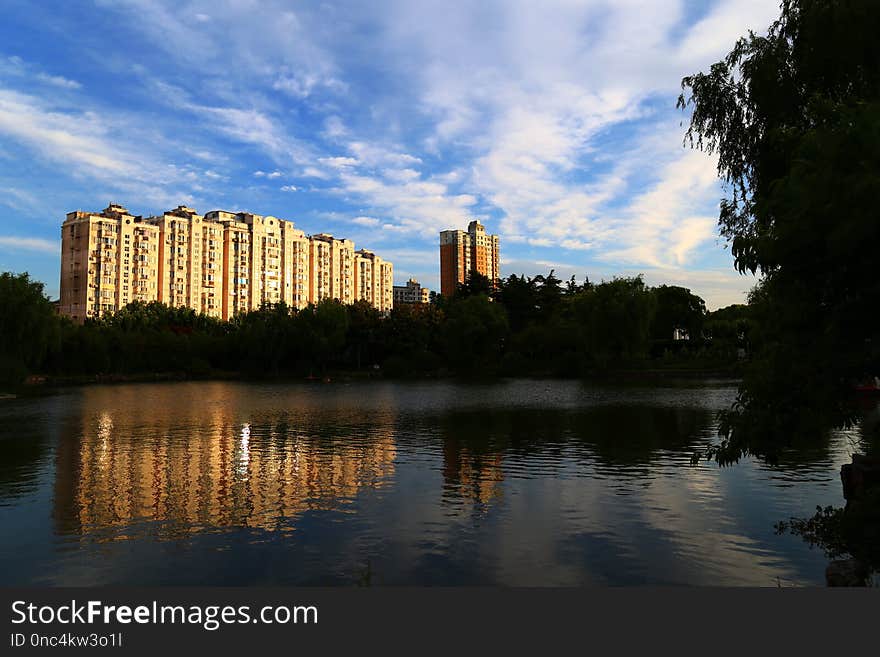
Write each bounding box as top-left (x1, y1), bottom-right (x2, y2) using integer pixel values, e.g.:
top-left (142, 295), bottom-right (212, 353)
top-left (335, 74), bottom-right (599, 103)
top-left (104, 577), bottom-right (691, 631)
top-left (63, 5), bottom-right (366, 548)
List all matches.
top-left (0, 381), bottom-right (858, 586)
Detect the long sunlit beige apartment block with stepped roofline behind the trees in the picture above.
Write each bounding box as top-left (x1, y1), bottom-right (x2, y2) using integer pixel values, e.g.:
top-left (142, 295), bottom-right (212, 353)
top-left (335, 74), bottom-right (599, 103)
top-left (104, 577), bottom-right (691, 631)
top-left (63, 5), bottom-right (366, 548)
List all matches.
top-left (59, 204), bottom-right (393, 322)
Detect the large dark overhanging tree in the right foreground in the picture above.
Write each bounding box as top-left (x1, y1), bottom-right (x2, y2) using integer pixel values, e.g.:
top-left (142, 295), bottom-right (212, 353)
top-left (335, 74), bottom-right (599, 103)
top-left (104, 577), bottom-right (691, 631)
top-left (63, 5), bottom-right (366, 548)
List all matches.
top-left (678, 0), bottom-right (880, 462)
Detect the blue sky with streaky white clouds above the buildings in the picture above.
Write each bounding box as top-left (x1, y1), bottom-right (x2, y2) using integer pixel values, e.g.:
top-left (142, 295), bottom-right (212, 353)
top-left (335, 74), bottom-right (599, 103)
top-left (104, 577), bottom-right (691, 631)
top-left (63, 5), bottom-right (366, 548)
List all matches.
top-left (0, 0), bottom-right (779, 309)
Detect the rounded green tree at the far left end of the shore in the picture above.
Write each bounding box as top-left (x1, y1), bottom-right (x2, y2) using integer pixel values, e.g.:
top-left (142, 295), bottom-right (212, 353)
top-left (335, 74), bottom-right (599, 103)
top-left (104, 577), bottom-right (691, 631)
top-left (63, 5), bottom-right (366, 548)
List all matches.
top-left (0, 272), bottom-right (60, 384)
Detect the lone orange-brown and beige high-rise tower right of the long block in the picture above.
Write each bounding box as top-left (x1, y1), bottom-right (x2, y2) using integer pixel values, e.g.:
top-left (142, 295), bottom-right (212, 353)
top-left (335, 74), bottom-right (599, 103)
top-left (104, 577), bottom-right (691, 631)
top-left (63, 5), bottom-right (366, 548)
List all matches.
top-left (440, 220), bottom-right (501, 296)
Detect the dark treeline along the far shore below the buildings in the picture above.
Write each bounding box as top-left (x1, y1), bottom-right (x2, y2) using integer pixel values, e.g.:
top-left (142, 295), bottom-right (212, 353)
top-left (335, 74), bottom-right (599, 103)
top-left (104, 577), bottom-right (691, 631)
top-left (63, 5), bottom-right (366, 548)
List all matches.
top-left (0, 271), bottom-right (749, 384)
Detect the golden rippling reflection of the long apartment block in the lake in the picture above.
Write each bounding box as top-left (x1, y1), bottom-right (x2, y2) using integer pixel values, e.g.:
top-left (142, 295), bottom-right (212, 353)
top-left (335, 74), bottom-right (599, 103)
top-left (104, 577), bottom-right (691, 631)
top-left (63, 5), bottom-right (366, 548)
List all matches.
top-left (55, 390), bottom-right (396, 540)
